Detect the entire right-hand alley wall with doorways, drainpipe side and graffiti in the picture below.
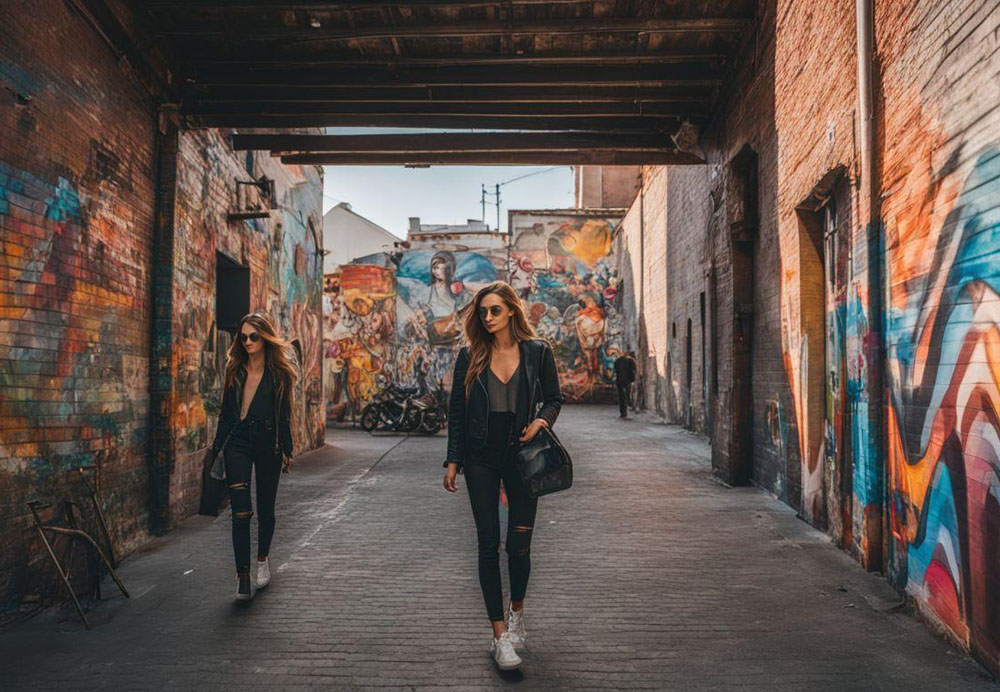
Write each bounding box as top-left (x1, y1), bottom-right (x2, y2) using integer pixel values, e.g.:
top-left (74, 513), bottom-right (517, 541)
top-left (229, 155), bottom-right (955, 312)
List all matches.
top-left (619, 0), bottom-right (1000, 672)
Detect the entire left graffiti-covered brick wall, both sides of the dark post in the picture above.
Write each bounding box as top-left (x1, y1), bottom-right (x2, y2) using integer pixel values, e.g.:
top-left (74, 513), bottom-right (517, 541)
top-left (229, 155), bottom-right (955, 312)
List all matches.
top-left (0, 0), bottom-right (322, 622)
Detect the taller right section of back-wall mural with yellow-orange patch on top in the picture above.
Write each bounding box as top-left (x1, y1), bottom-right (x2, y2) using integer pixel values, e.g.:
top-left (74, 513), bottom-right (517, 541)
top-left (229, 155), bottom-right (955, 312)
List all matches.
top-left (509, 211), bottom-right (625, 402)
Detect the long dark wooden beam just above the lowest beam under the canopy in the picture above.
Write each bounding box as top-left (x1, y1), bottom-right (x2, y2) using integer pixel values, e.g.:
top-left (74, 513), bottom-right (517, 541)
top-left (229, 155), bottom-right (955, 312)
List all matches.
top-left (232, 132), bottom-right (673, 153)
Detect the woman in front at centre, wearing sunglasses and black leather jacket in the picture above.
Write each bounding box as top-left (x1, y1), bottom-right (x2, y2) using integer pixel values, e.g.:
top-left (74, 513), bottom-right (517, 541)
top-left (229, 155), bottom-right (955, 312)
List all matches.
top-left (444, 281), bottom-right (562, 670)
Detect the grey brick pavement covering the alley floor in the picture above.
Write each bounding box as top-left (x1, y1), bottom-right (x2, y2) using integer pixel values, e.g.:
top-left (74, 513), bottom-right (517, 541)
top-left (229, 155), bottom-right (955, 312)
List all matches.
top-left (0, 407), bottom-right (1000, 692)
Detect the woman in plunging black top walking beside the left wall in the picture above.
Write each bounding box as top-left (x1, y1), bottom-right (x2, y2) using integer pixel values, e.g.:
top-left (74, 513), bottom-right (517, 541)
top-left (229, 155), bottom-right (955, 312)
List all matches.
top-left (212, 312), bottom-right (296, 601)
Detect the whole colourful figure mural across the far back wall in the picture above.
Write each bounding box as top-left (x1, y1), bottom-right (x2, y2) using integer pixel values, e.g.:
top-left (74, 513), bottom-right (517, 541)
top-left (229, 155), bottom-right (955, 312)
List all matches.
top-left (324, 211), bottom-right (623, 420)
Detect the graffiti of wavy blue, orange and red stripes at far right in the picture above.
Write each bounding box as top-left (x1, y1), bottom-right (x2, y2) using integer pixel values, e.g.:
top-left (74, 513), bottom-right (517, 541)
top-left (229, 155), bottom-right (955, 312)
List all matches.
top-left (886, 147), bottom-right (1000, 660)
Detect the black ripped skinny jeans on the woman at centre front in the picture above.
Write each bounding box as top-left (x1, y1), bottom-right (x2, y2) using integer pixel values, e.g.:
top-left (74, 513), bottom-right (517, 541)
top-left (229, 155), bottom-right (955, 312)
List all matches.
top-left (465, 413), bottom-right (538, 621)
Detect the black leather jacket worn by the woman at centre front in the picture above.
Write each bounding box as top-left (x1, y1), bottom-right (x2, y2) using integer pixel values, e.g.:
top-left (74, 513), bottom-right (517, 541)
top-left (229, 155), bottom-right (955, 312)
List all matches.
top-left (444, 339), bottom-right (563, 468)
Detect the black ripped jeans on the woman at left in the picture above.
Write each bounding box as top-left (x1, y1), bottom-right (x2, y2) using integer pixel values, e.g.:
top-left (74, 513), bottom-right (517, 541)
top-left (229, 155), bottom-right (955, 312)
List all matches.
top-left (225, 418), bottom-right (281, 572)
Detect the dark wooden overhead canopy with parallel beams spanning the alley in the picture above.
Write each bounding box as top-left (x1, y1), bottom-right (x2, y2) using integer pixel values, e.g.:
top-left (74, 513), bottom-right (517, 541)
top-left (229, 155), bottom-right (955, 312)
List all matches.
top-left (132, 0), bottom-right (755, 164)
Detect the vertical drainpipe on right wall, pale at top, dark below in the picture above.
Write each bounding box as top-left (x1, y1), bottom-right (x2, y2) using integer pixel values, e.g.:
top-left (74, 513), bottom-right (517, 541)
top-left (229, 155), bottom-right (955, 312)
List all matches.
top-left (852, 0), bottom-right (889, 571)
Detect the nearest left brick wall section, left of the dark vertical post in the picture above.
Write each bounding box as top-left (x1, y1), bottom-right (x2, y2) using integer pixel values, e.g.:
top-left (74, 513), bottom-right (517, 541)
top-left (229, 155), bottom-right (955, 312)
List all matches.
top-left (0, 0), bottom-right (155, 620)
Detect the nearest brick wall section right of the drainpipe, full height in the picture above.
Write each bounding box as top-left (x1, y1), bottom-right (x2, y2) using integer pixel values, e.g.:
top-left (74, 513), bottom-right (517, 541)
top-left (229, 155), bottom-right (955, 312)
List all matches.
top-left (876, 0), bottom-right (1000, 672)
